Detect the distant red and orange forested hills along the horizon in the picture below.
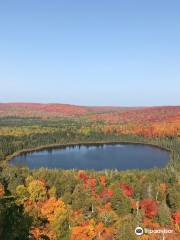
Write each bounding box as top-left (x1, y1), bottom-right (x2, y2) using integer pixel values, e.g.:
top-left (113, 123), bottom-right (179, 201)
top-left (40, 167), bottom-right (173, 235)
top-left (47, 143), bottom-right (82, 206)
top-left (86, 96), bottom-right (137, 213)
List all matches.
top-left (0, 103), bottom-right (180, 137)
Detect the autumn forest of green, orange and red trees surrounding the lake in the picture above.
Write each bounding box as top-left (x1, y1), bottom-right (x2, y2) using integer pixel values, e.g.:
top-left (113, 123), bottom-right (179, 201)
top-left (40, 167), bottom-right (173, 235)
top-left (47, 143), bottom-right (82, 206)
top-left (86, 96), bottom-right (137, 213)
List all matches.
top-left (0, 103), bottom-right (180, 240)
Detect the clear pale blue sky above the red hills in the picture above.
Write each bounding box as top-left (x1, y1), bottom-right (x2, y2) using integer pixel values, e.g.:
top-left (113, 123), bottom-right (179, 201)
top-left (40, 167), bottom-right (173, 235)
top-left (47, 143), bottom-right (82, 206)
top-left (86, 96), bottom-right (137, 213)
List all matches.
top-left (0, 0), bottom-right (180, 106)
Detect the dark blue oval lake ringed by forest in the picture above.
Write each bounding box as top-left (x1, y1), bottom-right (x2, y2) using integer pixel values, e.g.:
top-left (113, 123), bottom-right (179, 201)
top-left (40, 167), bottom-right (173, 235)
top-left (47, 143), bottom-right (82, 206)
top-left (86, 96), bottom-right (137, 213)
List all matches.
top-left (11, 144), bottom-right (169, 170)
